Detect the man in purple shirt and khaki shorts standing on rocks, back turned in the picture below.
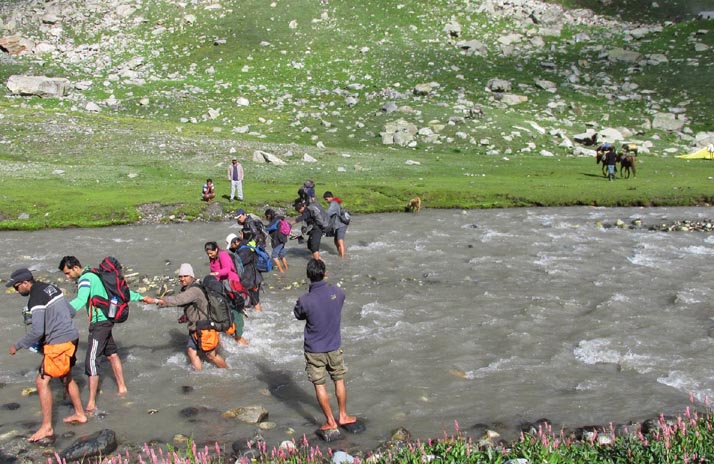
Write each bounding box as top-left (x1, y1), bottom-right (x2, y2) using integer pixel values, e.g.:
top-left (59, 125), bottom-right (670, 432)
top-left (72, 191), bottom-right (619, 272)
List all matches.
top-left (293, 258), bottom-right (357, 431)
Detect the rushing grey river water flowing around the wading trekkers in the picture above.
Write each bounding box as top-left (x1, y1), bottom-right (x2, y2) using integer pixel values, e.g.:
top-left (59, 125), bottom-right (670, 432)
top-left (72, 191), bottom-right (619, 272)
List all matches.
top-left (0, 207), bottom-right (714, 456)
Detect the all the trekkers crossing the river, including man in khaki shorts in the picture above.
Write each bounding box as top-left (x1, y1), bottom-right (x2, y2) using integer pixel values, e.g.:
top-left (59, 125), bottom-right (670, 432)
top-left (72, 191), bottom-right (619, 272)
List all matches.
top-left (6, 181), bottom-right (356, 441)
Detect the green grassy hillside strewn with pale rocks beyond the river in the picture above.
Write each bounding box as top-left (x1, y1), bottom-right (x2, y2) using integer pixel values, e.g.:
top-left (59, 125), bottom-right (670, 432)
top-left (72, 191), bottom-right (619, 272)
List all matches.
top-left (0, 0), bottom-right (714, 229)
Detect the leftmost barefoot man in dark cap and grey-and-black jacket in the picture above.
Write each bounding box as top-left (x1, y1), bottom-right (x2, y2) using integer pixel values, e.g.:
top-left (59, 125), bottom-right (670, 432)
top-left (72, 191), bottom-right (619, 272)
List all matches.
top-left (5, 268), bottom-right (87, 441)
